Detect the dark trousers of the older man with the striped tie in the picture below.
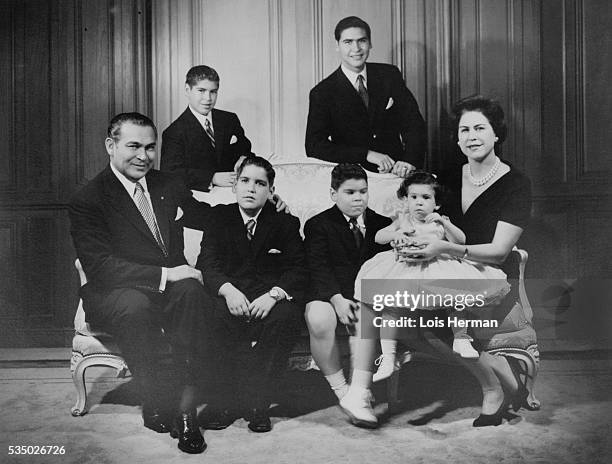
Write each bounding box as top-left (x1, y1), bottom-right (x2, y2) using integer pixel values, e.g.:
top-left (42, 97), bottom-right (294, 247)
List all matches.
top-left (84, 279), bottom-right (207, 401)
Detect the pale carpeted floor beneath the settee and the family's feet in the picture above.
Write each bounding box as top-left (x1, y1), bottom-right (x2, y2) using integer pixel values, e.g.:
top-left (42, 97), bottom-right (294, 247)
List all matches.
top-left (0, 349), bottom-right (612, 464)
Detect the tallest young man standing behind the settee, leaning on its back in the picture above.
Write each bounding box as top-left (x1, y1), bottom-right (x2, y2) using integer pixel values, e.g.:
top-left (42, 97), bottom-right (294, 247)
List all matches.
top-left (306, 16), bottom-right (426, 177)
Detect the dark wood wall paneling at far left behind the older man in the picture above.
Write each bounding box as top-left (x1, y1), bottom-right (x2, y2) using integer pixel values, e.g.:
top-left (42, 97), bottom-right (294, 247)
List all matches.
top-left (0, 0), bottom-right (151, 346)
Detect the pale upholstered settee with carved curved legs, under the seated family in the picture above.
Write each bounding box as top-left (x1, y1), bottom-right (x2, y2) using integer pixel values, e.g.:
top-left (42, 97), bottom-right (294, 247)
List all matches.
top-left (71, 162), bottom-right (539, 416)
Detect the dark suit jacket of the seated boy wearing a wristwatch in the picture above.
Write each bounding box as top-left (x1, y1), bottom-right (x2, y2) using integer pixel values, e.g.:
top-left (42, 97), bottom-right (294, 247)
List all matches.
top-left (196, 202), bottom-right (306, 300)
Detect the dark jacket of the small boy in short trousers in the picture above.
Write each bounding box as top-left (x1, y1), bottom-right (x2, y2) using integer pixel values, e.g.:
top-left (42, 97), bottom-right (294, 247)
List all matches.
top-left (304, 205), bottom-right (391, 301)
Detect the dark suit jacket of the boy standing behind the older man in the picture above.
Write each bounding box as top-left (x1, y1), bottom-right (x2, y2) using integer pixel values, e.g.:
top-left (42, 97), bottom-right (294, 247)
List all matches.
top-left (161, 108), bottom-right (251, 191)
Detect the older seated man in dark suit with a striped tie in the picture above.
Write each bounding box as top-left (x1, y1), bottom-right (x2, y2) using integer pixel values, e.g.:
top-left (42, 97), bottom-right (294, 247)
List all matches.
top-left (69, 113), bottom-right (210, 453)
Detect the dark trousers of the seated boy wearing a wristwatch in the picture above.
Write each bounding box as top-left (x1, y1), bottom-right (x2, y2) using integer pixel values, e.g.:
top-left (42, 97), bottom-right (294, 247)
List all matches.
top-left (205, 297), bottom-right (303, 408)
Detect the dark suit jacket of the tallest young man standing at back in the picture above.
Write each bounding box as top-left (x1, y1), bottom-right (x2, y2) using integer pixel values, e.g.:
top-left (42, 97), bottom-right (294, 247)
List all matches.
top-left (306, 63), bottom-right (426, 172)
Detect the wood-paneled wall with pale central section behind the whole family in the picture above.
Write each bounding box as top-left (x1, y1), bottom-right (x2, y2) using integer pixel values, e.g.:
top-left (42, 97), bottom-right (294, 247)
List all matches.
top-left (0, 0), bottom-right (612, 346)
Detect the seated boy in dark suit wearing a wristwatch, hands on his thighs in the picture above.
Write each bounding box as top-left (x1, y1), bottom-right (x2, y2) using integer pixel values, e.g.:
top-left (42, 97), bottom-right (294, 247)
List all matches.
top-left (196, 156), bottom-right (306, 432)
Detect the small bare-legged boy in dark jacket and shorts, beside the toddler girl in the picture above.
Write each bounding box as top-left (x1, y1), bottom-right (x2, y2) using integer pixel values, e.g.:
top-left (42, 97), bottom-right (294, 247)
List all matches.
top-left (304, 163), bottom-right (391, 426)
